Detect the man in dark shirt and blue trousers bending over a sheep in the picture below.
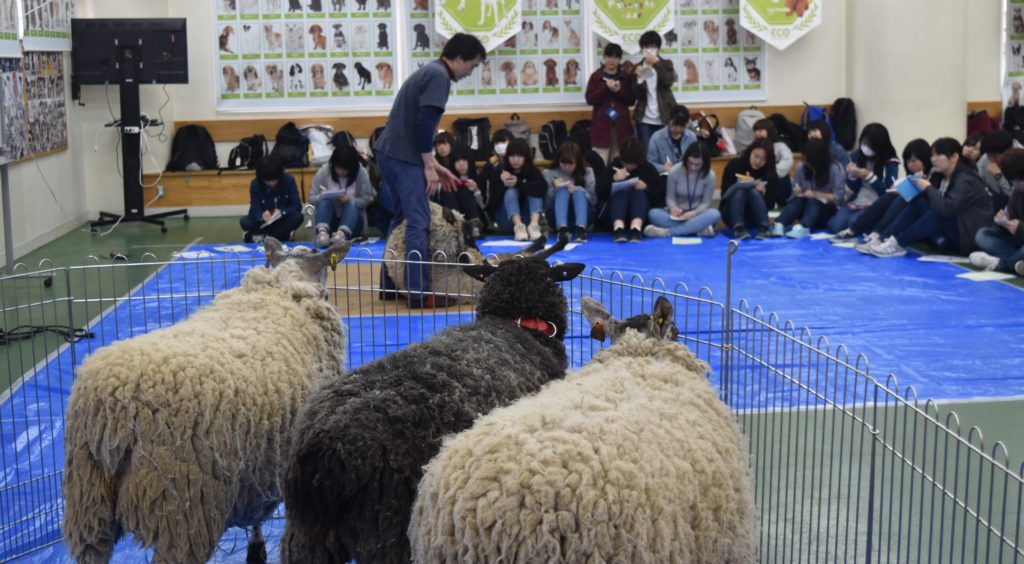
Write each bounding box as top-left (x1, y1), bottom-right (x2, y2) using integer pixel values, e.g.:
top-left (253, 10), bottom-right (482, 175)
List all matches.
top-left (374, 34), bottom-right (487, 308)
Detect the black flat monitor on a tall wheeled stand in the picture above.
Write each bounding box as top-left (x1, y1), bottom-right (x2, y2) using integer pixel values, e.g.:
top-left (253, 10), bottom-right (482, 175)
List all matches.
top-left (71, 18), bottom-right (188, 85)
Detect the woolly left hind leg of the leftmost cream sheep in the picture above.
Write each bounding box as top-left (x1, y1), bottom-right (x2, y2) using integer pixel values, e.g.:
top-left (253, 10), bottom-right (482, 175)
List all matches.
top-left (62, 448), bottom-right (121, 563)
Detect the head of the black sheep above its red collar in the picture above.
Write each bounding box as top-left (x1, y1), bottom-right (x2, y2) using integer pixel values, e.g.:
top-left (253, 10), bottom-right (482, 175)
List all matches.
top-left (464, 257), bottom-right (584, 340)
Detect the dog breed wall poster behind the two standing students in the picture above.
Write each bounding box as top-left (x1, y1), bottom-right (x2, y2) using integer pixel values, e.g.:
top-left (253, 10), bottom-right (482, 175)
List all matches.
top-left (593, 0), bottom-right (767, 103)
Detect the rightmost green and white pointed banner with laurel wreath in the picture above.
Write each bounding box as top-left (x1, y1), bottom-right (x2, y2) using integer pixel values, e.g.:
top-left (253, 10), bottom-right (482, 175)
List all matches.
top-left (739, 0), bottom-right (821, 50)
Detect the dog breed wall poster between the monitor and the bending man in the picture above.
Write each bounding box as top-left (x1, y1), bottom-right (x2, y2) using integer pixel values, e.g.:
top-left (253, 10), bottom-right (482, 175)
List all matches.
top-left (213, 0), bottom-right (393, 111)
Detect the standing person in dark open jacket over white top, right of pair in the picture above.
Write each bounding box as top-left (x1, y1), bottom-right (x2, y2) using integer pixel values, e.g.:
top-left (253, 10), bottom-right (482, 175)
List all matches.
top-left (633, 31), bottom-right (677, 147)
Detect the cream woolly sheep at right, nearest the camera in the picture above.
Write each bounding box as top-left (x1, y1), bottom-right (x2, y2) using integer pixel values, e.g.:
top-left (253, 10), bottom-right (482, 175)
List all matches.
top-left (409, 298), bottom-right (758, 563)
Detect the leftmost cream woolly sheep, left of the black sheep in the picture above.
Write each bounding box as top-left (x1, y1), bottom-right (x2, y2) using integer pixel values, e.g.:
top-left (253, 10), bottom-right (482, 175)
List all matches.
top-left (62, 237), bottom-right (351, 562)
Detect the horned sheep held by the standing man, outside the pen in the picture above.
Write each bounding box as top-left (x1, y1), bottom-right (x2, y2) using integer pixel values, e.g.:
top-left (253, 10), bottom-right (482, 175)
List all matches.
top-left (384, 202), bottom-right (568, 303)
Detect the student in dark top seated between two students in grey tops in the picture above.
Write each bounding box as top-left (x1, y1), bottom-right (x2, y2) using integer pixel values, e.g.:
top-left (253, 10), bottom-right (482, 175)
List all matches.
top-left (597, 137), bottom-right (665, 243)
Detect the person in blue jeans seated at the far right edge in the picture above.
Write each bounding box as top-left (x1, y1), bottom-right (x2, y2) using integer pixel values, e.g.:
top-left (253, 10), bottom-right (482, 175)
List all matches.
top-left (968, 148), bottom-right (1024, 276)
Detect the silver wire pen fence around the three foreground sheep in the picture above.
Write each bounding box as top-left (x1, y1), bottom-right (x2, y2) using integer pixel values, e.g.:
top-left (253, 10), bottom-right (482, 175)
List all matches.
top-left (0, 247), bottom-right (1024, 562)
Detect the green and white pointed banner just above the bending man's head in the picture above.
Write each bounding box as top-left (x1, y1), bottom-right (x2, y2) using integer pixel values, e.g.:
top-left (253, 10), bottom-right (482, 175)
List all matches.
top-left (434, 0), bottom-right (522, 51)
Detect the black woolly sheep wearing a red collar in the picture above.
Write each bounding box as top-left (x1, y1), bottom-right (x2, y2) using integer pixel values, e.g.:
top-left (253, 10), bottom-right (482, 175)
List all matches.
top-left (281, 257), bottom-right (584, 564)
